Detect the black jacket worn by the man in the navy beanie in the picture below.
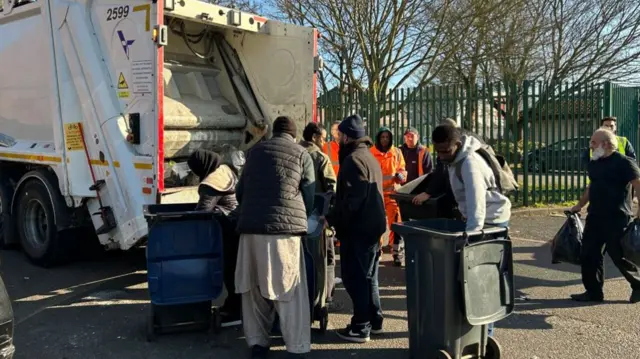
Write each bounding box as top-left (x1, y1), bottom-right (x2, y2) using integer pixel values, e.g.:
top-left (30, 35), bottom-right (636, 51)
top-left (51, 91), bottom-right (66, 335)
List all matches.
top-left (327, 137), bottom-right (386, 244)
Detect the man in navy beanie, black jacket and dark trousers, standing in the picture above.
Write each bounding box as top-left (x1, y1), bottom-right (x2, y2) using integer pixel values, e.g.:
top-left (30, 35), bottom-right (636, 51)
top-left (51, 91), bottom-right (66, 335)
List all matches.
top-left (327, 115), bottom-right (386, 343)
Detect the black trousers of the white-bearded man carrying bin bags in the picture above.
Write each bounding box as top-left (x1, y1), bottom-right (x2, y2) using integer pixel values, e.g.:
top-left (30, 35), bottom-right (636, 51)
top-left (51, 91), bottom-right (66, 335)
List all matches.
top-left (580, 215), bottom-right (640, 296)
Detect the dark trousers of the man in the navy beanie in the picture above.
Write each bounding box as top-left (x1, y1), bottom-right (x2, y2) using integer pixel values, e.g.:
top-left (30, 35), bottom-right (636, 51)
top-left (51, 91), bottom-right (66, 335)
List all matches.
top-left (340, 238), bottom-right (383, 330)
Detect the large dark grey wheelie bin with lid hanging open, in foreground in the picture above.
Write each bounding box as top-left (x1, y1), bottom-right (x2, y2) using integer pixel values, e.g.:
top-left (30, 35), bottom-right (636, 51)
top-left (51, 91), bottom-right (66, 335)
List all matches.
top-left (393, 219), bottom-right (515, 359)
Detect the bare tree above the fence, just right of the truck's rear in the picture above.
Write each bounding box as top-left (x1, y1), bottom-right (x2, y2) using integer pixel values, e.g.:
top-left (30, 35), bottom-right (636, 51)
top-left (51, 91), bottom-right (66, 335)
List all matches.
top-left (273, 0), bottom-right (473, 99)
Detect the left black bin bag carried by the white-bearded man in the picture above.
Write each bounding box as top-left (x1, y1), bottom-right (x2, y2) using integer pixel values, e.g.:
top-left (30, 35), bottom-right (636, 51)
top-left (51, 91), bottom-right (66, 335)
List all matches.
top-left (551, 211), bottom-right (584, 265)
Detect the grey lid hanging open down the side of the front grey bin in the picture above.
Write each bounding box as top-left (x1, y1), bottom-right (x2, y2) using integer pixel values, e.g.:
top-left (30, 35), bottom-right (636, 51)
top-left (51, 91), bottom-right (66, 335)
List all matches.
top-left (460, 239), bottom-right (515, 325)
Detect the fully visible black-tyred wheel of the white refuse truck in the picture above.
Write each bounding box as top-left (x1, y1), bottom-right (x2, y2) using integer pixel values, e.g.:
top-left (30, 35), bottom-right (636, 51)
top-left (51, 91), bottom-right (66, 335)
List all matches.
top-left (14, 180), bottom-right (67, 267)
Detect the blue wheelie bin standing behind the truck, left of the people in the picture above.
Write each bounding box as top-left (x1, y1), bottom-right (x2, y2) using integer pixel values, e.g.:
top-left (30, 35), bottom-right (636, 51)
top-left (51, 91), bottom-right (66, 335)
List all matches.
top-left (144, 204), bottom-right (224, 341)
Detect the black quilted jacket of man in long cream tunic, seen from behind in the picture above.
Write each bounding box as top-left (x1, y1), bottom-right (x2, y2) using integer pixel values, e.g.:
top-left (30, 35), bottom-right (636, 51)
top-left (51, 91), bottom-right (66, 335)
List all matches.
top-left (236, 133), bottom-right (316, 235)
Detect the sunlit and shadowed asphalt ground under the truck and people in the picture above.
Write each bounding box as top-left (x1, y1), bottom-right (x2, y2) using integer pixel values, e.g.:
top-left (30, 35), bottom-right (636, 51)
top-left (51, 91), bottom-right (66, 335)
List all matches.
top-left (1, 217), bottom-right (640, 359)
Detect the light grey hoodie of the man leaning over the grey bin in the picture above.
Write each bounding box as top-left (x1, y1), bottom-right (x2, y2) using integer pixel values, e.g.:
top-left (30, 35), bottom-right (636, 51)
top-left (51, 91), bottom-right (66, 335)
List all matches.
top-left (449, 136), bottom-right (511, 231)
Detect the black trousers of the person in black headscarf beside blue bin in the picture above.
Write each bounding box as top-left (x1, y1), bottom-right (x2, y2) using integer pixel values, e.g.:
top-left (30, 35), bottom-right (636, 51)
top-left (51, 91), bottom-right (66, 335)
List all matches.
top-left (215, 214), bottom-right (242, 314)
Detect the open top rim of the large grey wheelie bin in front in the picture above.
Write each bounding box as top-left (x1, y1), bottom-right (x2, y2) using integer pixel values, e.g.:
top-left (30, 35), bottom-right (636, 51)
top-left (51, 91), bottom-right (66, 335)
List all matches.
top-left (392, 218), bottom-right (507, 237)
